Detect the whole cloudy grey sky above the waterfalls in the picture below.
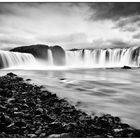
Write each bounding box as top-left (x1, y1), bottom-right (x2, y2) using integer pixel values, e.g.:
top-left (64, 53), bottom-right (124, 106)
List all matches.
top-left (0, 2), bottom-right (140, 50)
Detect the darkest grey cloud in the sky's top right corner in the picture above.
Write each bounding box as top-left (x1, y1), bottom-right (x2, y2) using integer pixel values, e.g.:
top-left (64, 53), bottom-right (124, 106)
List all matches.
top-left (88, 2), bottom-right (140, 21)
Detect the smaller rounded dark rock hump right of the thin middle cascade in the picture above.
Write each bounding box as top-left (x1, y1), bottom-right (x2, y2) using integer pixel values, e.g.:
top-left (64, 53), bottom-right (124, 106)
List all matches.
top-left (50, 46), bottom-right (65, 65)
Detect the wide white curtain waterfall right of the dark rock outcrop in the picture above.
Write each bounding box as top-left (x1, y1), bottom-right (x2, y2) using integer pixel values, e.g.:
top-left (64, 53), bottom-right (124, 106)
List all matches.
top-left (66, 47), bottom-right (140, 67)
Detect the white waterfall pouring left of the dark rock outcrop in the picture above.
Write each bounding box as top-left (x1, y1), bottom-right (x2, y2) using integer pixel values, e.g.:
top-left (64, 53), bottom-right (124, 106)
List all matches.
top-left (0, 50), bottom-right (36, 68)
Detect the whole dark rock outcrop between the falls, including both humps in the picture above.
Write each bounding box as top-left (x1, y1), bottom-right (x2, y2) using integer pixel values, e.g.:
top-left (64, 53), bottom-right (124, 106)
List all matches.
top-left (10, 44), bottom-right (65, 65)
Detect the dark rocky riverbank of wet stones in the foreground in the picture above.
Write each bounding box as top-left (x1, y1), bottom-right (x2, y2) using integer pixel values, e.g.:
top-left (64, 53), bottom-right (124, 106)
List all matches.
top-left (0, 73), bottom-right (140, 138)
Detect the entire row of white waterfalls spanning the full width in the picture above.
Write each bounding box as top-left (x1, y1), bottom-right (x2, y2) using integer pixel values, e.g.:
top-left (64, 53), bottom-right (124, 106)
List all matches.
top-left (0, 47), bottom-right (140, 69)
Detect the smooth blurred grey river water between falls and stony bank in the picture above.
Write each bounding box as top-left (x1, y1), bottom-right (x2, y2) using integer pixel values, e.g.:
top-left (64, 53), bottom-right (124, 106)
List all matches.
top-left (0, 68), bottom-right (140, 128)
